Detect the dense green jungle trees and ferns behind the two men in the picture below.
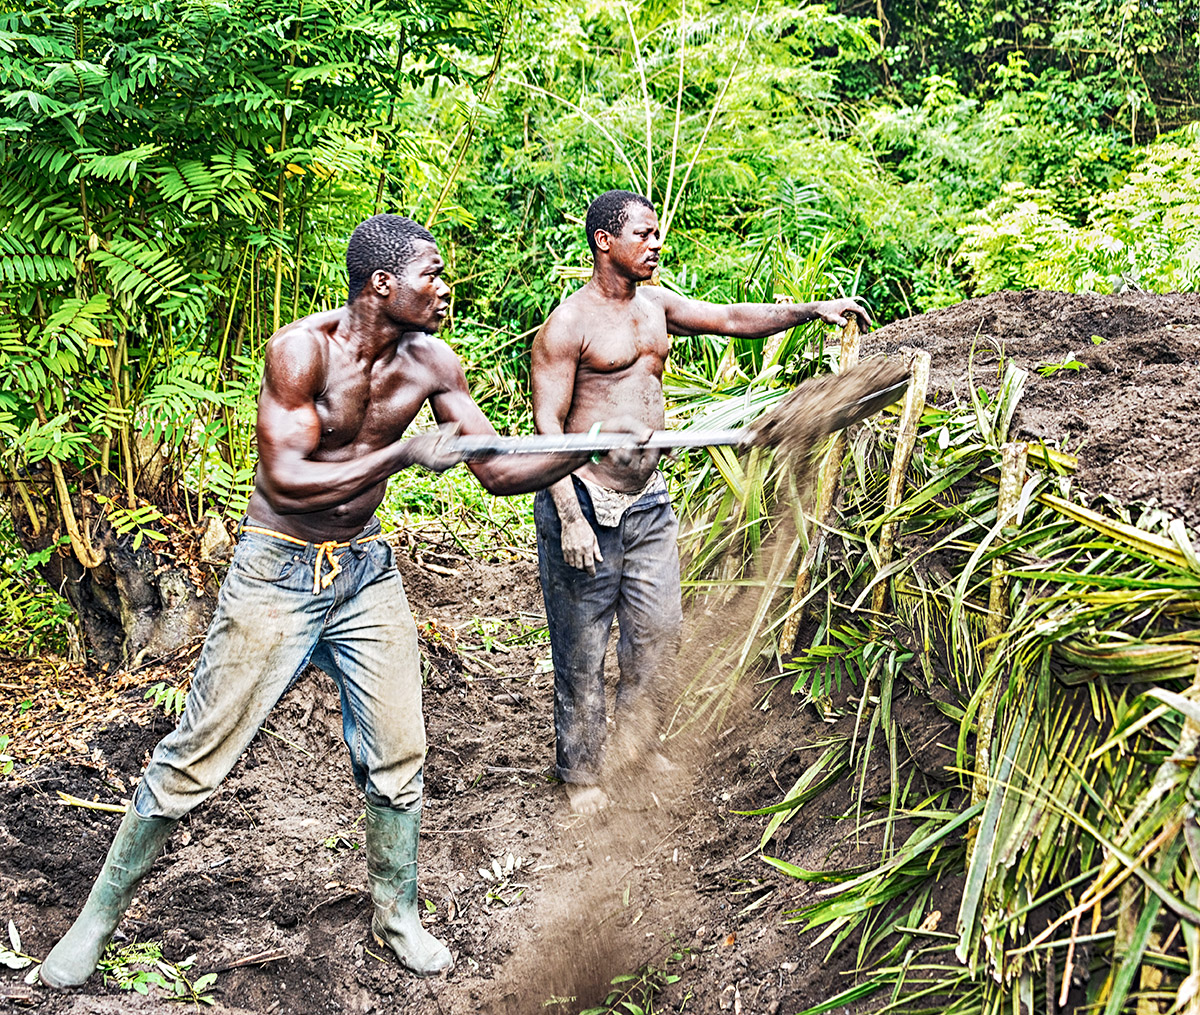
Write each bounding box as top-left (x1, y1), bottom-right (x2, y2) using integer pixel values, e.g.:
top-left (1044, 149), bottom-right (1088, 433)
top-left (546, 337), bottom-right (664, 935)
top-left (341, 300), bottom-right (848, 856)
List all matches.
top-left (0, 0), bottom-right (1200, 661)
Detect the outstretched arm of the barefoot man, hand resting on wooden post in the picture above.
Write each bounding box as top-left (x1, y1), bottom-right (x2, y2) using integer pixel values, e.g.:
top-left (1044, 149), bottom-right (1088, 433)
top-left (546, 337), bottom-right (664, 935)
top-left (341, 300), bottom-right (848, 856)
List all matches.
top-left (641, 287), bottom-right (871, 338)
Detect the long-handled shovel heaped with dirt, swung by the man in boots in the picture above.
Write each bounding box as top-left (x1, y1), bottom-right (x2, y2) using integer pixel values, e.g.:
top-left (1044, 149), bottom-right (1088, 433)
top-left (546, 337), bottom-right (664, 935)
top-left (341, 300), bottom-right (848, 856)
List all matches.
top-left (448, 360), bottom-right (908, 462)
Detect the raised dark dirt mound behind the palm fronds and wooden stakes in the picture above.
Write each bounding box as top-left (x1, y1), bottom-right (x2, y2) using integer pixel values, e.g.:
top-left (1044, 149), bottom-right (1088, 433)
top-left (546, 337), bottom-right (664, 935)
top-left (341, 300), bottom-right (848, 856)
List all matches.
top-left (862, 290), bottom-right (1200, 530)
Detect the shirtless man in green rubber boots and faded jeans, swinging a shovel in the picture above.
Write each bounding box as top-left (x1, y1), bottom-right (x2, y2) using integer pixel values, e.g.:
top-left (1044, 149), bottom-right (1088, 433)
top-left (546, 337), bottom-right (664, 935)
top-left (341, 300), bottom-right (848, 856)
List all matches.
top-left (41, 215), bottom-right (648, 987)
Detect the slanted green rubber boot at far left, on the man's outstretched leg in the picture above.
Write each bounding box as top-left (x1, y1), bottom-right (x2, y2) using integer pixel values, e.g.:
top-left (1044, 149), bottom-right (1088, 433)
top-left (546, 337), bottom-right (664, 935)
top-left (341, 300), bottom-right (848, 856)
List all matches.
top-left (41, 806), bottom-right (179, 987)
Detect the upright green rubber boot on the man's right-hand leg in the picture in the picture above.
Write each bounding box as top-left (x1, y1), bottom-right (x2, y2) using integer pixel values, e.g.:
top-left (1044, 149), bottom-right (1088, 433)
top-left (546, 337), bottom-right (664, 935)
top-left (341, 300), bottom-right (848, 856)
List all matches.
top-left (366, 800), bottom-right (454, 977)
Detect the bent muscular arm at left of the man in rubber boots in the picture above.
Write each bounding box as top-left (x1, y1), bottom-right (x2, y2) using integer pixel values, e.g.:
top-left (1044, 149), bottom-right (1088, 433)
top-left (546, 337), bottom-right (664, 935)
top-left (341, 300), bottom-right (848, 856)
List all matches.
top-left (258, 330), bottom-right (460, 515)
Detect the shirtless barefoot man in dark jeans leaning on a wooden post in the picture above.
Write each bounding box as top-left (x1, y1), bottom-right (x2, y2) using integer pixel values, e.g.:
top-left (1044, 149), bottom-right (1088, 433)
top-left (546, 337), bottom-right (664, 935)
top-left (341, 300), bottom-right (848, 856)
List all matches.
top-left (533, 191), bottom-right (870, 813)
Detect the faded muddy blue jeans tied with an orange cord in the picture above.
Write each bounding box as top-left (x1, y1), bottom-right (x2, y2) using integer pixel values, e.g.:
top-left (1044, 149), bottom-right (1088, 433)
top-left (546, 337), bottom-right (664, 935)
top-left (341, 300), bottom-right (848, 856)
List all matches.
top-left (133, 519), bottom-right (425, 818)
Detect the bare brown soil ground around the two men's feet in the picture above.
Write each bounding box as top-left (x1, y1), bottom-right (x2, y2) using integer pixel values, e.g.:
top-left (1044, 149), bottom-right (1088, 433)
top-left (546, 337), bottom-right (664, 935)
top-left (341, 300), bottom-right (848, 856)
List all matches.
top-left (0, 558), bottom-right (875, 1015)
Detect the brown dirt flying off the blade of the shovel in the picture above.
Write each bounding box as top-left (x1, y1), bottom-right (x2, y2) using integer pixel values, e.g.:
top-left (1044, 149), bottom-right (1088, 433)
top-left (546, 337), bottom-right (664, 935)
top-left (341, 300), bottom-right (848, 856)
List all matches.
top-left (752, 356), bottom-right (910, 464)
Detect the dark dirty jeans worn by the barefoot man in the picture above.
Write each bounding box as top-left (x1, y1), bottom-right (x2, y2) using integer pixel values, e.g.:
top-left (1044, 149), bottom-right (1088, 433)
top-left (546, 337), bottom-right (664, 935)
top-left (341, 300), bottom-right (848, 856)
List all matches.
top-left (534, 478), bottom-right (682, 785)
